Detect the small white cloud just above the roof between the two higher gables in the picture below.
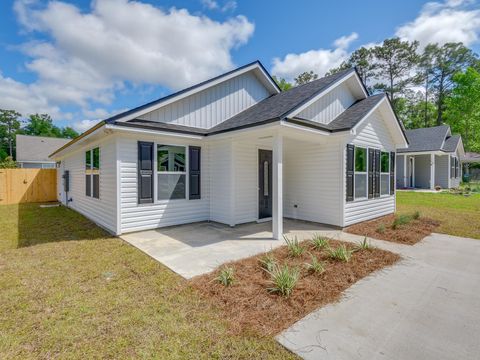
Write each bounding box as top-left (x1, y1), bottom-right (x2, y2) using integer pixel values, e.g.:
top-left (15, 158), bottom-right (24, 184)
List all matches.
top-left (272, 33), bottom-right (358, 81)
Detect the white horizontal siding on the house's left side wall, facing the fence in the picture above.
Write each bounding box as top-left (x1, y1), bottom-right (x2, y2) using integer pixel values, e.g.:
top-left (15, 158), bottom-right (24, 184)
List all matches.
top-left (57, 136), bottom-right (117, 233)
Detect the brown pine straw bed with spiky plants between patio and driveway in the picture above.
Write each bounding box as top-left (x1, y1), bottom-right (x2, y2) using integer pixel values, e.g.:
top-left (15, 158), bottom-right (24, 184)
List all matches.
top-left (191, 240), bottom-right (400, 336)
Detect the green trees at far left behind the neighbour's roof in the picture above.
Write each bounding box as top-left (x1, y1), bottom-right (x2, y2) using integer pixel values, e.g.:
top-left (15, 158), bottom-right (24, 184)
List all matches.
top-left (0, 109), bottom-right (78, 162)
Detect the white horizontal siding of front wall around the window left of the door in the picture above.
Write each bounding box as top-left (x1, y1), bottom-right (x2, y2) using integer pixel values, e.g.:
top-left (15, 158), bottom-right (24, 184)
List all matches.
top-left (117, 136), bottom-right (210, 233)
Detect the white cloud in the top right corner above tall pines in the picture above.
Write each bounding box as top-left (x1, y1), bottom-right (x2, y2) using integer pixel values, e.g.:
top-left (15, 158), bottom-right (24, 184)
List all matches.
top-left (395, 0), bottom-right (480, 48)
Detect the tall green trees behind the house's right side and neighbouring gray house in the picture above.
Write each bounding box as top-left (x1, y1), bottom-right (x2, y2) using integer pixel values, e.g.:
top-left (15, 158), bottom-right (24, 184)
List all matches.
top-left (275, 38), bottom-right (480, 152)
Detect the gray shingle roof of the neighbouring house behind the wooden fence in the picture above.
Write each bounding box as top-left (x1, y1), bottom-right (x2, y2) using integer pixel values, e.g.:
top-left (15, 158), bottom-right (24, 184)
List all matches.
top-left (16, 135), bottom-right (72, 162)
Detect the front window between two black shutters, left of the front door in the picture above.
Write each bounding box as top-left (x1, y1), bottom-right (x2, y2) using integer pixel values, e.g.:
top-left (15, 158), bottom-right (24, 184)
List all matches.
top-left (157, 145), bottom-right (187, 200)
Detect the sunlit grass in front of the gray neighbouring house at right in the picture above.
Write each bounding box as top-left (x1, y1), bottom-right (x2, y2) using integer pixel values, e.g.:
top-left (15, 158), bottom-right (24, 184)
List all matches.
top-left (397, 191), bottom-right (480, 239)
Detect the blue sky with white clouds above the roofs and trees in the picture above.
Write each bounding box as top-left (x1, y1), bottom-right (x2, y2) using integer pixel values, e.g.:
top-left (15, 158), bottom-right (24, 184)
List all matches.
top-left (0, 0), bottom-right (480, 130)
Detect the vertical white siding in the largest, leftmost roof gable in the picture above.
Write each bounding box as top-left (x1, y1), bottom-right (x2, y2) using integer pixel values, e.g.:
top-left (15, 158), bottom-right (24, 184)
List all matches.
top-left (139, 72), bottom-right (270, 129)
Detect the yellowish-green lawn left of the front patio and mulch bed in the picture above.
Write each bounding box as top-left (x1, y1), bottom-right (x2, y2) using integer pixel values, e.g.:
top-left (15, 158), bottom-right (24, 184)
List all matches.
top-left (0, 204), bottom-right (294, 359)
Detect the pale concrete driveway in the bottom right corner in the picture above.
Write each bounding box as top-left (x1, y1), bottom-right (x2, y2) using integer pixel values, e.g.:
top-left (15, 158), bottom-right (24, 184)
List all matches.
top-left (277, 234), bottom-right (480, 360)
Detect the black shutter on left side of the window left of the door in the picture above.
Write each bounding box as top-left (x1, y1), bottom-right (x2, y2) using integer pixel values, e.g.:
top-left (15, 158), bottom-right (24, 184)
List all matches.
top-left (137, 141), bottom-right (153, 204)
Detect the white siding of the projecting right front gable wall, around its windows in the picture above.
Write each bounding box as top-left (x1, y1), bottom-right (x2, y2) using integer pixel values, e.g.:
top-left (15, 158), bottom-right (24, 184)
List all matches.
top-left (343, 109), bottom-right (395, 226)
